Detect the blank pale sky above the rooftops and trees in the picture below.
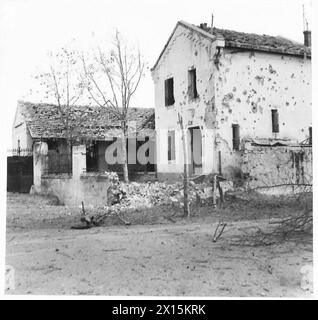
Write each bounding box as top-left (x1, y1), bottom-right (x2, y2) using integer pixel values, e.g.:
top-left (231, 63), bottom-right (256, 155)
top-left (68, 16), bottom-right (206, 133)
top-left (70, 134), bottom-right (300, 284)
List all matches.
top-left (0, 0), bottom-right (312, 146)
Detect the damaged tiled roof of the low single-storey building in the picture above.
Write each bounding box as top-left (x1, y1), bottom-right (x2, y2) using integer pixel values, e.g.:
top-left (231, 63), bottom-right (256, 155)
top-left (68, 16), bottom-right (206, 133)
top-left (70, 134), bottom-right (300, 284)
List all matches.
top-left (18, 101), bottom-right (155, 140)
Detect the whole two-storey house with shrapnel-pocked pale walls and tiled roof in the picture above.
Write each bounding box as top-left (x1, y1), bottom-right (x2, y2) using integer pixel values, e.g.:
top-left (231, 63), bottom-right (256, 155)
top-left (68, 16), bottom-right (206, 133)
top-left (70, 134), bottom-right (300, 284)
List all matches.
top-left (152, 21), bottom-right (312, 186)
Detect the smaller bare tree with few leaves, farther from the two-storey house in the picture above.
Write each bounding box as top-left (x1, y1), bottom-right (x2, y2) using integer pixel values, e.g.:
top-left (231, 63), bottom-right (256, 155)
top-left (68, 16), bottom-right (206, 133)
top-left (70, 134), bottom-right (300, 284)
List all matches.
top-left (35, 48), bottom-right (84, 147)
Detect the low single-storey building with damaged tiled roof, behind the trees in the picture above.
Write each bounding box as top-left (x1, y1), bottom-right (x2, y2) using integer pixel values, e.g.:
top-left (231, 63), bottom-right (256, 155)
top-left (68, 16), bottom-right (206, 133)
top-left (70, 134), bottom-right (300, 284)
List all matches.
top-left (12, 101), bottom-right (155, 205)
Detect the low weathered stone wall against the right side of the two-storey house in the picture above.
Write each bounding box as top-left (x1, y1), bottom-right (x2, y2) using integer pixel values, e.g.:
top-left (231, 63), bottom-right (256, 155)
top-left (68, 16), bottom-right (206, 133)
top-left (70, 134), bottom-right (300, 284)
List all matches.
top-left (241, 144), bottom-right (312, 193)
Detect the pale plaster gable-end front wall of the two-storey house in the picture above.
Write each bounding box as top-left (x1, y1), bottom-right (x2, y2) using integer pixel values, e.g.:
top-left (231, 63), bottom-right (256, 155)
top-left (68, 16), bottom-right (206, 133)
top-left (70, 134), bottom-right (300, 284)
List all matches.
top-left (153, 26), bottom-right (214, 173)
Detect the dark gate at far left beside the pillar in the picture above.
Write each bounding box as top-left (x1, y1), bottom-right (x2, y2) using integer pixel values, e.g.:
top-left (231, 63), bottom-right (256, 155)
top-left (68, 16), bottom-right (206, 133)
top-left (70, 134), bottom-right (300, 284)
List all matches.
top-left (7, 156), bottom-right (33, 193)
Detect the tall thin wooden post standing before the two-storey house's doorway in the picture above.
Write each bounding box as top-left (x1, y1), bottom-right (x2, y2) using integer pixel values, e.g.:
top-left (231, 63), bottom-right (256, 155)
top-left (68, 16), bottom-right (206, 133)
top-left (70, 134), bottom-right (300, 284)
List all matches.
top-left (178, 113), bottom-right (190, 219)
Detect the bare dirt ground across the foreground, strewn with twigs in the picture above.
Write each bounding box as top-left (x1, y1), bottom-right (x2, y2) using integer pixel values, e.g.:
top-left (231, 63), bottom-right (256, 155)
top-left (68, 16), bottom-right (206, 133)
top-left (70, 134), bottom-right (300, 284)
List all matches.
top-left (6, 193), bottom-right (313, 297)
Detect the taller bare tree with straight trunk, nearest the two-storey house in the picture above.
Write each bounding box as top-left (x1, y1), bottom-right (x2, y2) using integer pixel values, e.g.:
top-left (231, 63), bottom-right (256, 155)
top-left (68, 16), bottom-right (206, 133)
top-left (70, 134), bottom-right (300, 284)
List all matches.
top-left (81, 31), bottom-right (145, 182)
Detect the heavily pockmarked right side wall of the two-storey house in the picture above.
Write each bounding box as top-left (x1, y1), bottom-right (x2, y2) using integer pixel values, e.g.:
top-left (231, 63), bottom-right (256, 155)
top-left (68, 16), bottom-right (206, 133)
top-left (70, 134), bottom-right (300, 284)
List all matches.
top-left (215, 50), bottom-right (312, 175)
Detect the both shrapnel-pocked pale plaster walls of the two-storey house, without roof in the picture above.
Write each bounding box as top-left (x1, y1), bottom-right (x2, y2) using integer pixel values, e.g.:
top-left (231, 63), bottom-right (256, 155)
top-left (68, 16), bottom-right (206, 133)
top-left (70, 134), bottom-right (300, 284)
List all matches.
top-left (152, 22), bottom-right (312, 182)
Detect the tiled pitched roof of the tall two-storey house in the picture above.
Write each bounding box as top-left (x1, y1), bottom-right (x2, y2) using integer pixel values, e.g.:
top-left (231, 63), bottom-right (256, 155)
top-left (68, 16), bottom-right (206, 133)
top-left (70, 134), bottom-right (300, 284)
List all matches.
top-left (151, 21), bottom-right (311, 70)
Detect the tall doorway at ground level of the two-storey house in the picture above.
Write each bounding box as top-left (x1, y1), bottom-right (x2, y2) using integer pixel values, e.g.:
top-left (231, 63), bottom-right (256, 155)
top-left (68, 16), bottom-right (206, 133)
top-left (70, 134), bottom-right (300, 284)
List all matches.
top-left (188, 127), bottom-right (202, 174)
